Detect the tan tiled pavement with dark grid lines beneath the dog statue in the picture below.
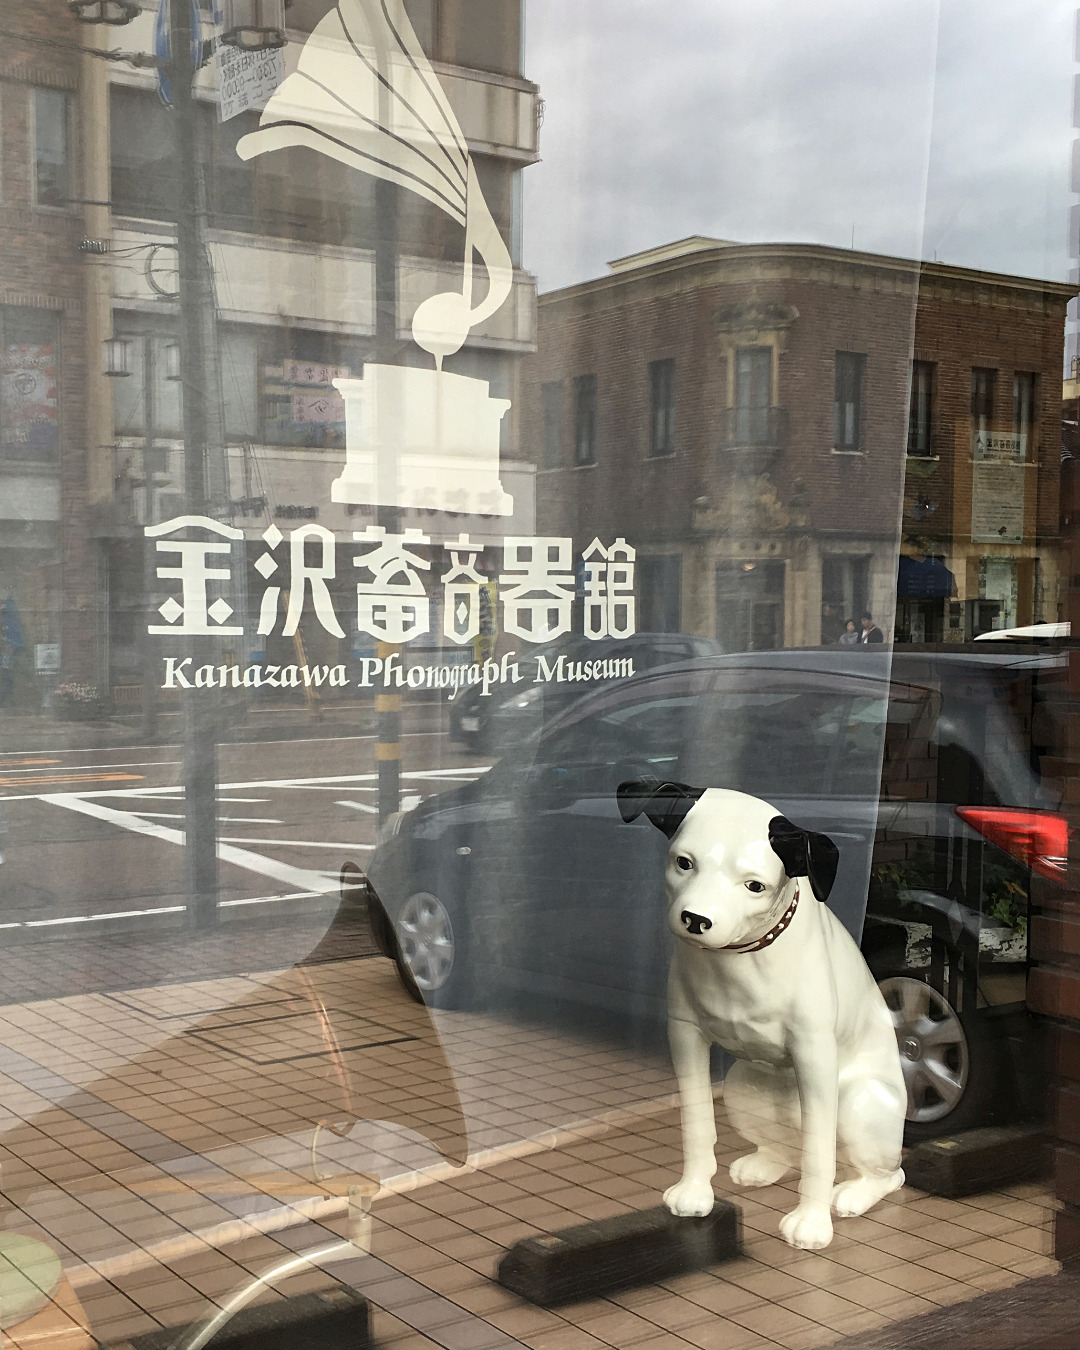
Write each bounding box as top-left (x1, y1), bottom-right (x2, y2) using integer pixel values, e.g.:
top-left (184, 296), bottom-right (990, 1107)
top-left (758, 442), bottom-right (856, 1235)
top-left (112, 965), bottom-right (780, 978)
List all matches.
top-left (0, 959), bottom-right (1054, 1350)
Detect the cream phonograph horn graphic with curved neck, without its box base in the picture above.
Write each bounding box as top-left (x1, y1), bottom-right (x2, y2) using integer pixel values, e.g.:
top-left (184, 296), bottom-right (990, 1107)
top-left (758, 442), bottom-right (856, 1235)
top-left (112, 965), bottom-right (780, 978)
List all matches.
top-left (236, 0), bottom-right (513, 369)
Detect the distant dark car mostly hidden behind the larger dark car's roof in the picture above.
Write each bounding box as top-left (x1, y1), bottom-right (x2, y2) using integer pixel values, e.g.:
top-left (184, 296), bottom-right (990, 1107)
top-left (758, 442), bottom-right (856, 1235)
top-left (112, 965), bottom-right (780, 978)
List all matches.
top-left (448, 633), bottom-right (720, 751)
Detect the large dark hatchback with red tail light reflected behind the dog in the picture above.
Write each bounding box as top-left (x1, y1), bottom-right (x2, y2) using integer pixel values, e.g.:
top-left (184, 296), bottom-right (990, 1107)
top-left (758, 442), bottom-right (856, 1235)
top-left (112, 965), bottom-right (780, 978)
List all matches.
top-left (370, 648), bottom-right (1067, 1138)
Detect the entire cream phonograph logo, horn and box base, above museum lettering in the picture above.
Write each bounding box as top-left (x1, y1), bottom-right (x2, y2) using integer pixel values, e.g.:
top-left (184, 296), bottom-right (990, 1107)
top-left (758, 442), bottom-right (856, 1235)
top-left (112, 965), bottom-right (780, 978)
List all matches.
top-left (236, 0), bottom-right (513, 516)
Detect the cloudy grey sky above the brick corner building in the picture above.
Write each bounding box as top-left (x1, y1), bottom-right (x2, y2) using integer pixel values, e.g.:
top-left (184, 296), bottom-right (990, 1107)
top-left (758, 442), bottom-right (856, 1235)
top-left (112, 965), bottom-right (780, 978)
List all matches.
top-left (524, 0), bottom-right (1076, 290)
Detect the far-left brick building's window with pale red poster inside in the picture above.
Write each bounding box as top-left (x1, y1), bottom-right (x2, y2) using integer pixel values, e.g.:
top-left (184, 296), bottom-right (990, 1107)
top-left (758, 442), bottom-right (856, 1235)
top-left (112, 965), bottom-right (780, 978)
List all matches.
top-left (0, 305), bottom-right (59, 463)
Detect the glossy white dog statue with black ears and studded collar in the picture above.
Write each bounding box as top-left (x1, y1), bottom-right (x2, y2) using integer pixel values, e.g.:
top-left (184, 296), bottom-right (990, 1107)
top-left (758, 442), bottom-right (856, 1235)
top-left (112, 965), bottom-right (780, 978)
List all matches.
top-left (618, 782), bottom-right (907, 1250)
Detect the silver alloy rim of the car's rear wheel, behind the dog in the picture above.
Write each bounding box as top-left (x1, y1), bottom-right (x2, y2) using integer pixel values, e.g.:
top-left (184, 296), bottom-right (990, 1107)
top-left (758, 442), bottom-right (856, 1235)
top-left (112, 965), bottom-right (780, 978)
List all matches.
top-left (879, 975), bottom-right (971, 1125)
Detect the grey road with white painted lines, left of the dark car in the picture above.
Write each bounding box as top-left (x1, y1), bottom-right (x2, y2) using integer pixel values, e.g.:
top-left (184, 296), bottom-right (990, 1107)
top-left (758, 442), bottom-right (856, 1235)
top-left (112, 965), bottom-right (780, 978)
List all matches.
top-left (0, 733), bottom-right (486, 937)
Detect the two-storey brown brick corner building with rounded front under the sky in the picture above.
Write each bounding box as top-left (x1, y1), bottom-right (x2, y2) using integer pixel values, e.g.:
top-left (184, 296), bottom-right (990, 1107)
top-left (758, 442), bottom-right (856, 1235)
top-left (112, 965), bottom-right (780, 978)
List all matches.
top-left (522, 239), bottom-right (1068, 648)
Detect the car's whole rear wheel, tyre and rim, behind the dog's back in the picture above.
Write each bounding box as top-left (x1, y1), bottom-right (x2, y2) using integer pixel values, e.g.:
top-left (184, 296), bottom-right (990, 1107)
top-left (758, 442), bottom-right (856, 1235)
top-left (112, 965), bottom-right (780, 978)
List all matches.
top-left (878, 975), bottom-right (999, 1143)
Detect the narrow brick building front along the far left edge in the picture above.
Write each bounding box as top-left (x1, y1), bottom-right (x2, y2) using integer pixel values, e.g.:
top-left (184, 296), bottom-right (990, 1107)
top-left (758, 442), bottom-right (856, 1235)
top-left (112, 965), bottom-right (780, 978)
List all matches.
top-left (0, 0), bottom-right (97, 702)
